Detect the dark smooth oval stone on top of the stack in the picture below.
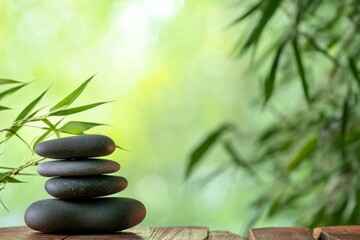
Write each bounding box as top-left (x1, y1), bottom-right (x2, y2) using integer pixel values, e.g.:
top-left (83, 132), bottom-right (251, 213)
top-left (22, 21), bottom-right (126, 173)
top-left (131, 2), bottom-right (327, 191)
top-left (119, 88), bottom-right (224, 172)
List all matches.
top-left (35, 135), bottom-right (116, 159)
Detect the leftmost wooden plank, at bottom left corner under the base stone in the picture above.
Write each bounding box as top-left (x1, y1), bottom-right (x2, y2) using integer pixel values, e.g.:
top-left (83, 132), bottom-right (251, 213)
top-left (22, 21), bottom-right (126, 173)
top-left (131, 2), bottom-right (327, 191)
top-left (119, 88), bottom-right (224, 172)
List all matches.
top-left (0, 227), bottom-right (68, 240)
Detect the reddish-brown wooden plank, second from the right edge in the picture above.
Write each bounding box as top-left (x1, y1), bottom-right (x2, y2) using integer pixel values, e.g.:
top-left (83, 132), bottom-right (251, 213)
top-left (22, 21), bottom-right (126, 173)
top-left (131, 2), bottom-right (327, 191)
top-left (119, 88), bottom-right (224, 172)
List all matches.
top-left (249, 228), bottom-right (314, 240)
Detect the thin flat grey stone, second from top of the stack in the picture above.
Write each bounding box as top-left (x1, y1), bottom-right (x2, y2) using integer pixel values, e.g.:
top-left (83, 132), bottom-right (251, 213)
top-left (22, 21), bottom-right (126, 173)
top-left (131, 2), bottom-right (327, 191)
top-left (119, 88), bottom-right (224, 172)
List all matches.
top-left (37, 158), bottom-right (120, 177)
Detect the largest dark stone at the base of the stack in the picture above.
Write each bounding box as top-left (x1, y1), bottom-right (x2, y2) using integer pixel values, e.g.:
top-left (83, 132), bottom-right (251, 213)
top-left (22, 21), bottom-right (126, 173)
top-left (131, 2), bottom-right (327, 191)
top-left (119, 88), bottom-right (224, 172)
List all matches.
top-left (25, 198), bottom-right (146, 233)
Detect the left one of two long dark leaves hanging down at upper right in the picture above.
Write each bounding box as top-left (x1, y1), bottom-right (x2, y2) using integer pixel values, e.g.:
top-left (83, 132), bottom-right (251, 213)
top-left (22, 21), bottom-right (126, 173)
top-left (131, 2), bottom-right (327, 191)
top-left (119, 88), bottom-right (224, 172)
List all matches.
top-left (264, 38), bottom-right (289, 104)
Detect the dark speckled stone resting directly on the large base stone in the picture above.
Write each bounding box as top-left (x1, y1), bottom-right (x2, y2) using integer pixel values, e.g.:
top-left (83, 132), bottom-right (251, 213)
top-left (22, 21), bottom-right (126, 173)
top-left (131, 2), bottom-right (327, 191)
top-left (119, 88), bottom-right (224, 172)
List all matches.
top-left (45, 175), bottom-right (127, 199)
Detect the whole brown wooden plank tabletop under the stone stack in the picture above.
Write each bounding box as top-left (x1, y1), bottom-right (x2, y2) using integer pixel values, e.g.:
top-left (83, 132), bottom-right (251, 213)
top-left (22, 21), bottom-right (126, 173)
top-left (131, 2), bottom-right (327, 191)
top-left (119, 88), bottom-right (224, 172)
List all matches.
top-left (0, 226), bottom-right (360, 240)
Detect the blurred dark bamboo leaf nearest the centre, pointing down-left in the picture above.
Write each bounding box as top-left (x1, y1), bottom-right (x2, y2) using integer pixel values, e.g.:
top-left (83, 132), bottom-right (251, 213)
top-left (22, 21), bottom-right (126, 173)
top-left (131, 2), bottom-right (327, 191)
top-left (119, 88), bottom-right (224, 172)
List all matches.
top-left (185, 124), bottom-right (230, 178)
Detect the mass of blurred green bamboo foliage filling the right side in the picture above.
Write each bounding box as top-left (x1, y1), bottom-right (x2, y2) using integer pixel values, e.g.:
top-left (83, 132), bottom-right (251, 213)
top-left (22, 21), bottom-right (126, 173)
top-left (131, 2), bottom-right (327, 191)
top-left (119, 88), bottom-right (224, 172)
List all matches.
top-left (186, 0), bottom-right (360, 230)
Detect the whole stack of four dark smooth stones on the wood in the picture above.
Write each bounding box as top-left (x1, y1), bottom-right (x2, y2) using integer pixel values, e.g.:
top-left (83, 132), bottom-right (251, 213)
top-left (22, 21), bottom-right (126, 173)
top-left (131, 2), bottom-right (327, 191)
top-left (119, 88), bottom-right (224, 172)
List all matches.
top-left (25, 135), bottom-right (146, 233)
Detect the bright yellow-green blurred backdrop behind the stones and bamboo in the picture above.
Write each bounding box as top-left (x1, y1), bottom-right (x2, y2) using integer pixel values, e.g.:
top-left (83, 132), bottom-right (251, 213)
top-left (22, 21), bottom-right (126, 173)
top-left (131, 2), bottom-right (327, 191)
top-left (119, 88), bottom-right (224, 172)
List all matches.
top-left (0, 0), bottom-right (276, 232)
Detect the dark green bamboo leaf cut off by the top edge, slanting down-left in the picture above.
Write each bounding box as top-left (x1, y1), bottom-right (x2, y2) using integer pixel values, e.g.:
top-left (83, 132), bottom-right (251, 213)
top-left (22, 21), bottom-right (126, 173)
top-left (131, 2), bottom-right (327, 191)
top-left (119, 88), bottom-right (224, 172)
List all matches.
top-left (243, 0), bottom-right (282, 49)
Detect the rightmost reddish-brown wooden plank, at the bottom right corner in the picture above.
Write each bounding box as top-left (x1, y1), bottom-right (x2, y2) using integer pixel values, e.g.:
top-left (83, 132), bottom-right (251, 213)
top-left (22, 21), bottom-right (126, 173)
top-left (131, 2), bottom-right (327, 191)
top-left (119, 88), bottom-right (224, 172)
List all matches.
top-left (314, 226), bottom-right (360, 240)
